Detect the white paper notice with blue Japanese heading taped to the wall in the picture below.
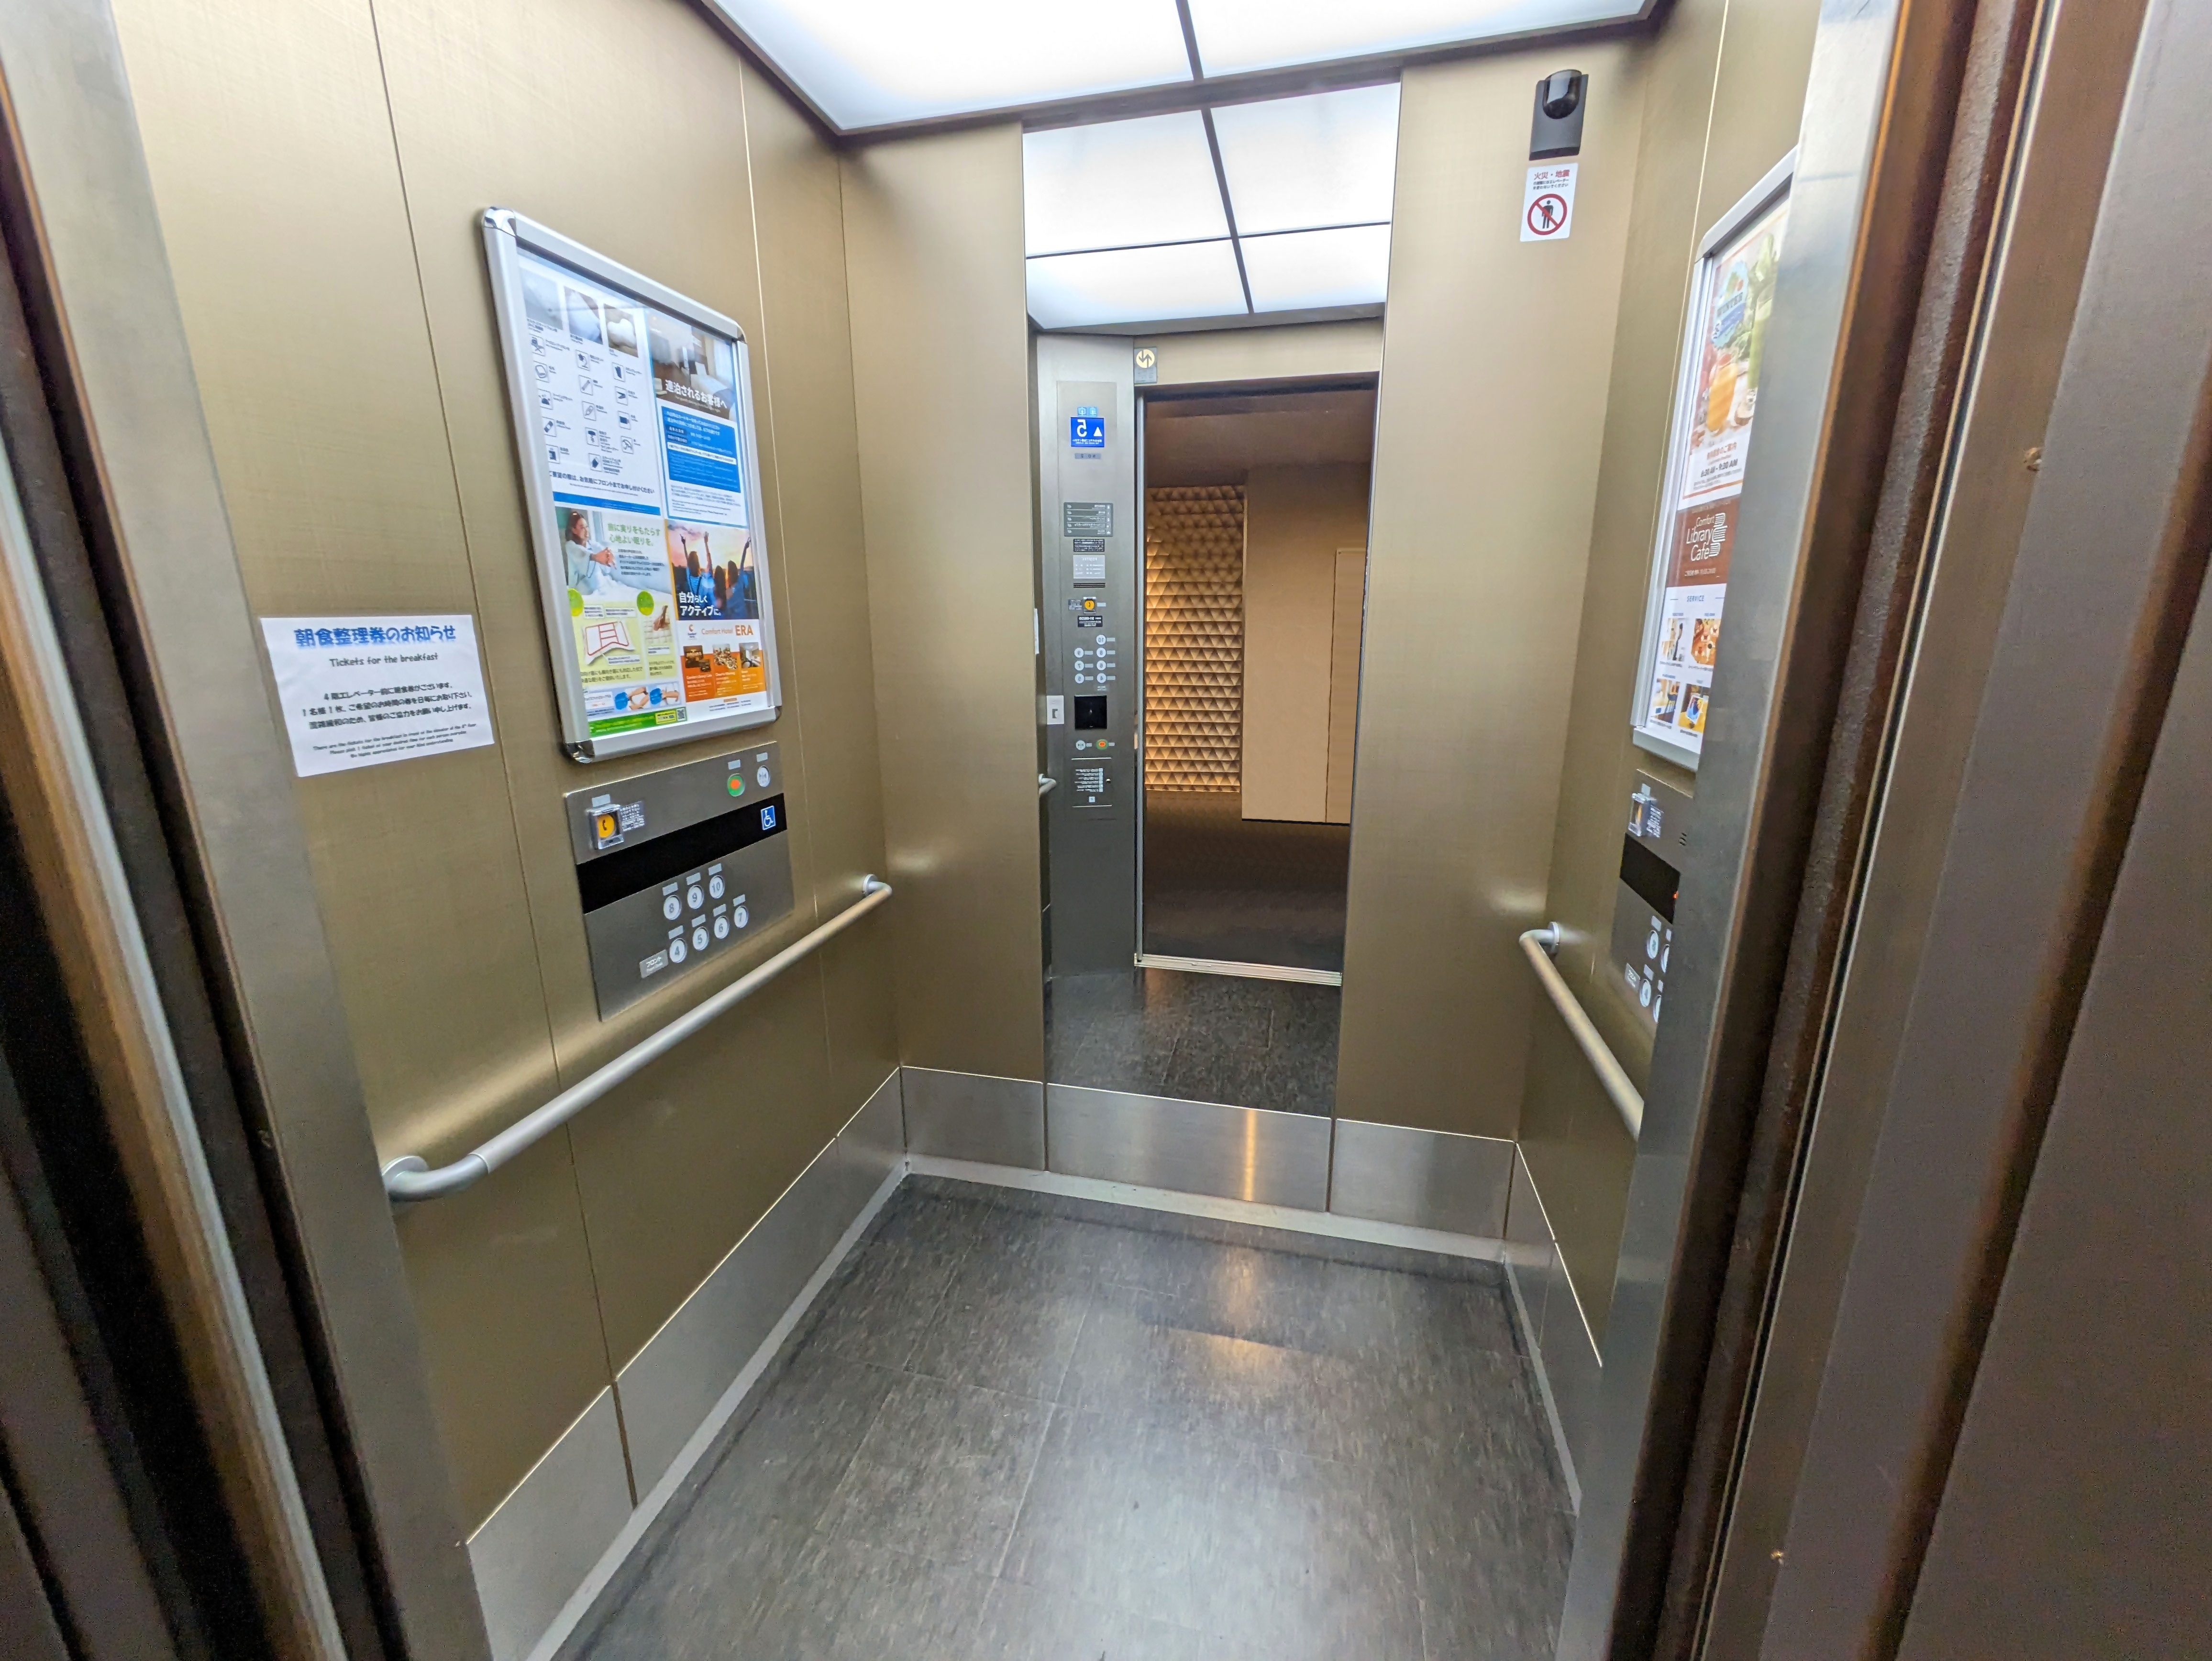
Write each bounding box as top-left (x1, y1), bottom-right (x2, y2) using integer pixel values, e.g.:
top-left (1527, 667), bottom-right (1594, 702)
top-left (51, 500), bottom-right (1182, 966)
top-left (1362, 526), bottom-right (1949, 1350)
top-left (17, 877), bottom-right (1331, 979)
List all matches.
top-left (261, 613), bottom-right (491, 778)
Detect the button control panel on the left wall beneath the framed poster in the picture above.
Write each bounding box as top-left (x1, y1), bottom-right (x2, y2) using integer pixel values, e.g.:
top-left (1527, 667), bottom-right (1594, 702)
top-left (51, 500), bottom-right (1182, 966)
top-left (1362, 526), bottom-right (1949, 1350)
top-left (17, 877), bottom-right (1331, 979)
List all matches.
top-left (562, 743), bottom-right (792, 1019)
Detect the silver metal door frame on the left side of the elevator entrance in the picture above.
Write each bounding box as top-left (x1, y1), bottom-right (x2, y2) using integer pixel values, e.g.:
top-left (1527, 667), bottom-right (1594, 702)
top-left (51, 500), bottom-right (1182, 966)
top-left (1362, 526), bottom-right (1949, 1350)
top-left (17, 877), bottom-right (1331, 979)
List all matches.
top-left (0, 0), bottom-right (489, 1661)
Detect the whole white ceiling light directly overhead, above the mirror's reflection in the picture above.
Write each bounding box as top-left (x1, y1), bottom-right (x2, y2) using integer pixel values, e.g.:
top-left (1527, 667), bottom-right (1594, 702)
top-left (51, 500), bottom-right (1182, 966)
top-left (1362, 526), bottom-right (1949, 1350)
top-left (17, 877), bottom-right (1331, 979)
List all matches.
top-left (712, 0), bottom-right (1657, 133)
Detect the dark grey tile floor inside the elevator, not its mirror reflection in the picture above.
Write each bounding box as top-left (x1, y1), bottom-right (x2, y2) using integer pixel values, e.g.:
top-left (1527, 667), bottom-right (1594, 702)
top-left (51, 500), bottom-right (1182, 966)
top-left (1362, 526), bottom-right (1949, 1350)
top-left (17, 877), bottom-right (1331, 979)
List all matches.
top-left (582, 1181), bottom-right (1573, 1661)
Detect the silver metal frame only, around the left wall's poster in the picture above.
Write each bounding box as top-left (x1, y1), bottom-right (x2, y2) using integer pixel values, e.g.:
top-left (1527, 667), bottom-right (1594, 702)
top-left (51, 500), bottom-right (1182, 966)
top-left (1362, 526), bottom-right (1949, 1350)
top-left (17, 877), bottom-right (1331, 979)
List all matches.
top-left (482, 208), bottom-right (783, 761)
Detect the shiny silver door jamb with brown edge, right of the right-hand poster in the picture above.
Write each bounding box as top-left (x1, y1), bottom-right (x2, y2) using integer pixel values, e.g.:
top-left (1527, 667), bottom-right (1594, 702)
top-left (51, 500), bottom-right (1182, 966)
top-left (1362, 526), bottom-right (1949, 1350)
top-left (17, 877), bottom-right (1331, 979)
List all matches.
top-left (1557, 0), bottom-right (2000, 1661)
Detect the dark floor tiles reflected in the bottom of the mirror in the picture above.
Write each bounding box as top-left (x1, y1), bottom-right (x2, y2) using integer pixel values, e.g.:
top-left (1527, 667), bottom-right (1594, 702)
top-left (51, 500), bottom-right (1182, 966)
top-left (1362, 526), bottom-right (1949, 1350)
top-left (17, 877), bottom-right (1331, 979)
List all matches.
top-left (1044, 969), bottom-right (1343, 1112)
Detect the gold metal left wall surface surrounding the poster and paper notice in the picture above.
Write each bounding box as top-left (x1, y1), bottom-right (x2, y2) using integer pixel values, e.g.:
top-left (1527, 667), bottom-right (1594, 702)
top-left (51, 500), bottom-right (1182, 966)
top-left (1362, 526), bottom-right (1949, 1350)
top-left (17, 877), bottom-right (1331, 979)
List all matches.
top-left (108, 0), bottom-right (902, 1526)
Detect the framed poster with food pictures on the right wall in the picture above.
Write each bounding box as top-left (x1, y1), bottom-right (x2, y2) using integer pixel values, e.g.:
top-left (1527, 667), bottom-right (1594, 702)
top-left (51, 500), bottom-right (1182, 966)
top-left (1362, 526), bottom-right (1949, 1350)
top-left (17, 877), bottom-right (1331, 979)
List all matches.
top-left (1628, 150), bottom-right (1796, 772)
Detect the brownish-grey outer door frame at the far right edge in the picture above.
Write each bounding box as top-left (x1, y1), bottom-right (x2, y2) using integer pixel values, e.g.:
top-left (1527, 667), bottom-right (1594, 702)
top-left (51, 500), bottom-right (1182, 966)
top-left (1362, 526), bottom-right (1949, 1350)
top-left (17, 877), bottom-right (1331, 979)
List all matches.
top-left (1708, 0), bottom-right (2212, 1657)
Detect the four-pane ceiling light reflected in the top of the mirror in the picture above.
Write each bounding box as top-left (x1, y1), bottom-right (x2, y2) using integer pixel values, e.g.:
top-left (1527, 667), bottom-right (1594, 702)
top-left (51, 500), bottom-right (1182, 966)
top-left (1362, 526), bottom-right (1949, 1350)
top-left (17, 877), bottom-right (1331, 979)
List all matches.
top-left (1022, 84), bottom-right (1398, 330)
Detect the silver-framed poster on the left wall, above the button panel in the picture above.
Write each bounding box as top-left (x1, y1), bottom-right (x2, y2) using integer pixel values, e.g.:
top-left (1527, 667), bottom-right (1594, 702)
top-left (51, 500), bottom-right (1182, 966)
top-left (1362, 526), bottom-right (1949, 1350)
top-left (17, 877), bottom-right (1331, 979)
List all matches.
top-left (485, 208), bottom-right (783, 761)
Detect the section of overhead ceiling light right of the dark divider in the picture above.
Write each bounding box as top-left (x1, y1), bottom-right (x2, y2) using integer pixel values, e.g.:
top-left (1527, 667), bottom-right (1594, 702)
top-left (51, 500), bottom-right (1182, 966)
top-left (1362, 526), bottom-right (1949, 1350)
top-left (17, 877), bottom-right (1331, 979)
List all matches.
top-left (1190, 0), bottom-right (1644, 75)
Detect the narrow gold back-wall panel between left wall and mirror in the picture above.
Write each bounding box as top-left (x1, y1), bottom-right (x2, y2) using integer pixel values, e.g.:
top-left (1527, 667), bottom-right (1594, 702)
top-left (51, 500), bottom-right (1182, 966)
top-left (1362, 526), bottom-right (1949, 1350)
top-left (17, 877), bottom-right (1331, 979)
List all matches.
top-left (845, 124), bottom-right (1044, 1079)
